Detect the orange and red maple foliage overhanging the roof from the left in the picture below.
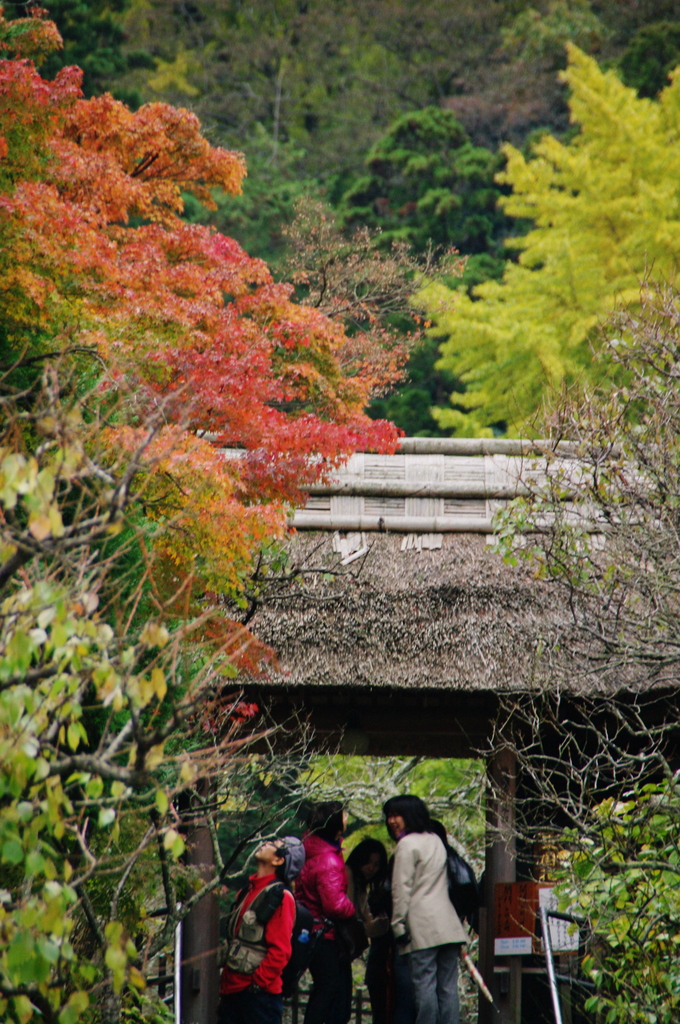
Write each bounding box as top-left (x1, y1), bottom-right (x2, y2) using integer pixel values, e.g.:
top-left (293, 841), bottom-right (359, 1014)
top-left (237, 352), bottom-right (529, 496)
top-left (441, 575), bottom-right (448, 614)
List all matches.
top-left (0, 11), bottom-right (398, 593)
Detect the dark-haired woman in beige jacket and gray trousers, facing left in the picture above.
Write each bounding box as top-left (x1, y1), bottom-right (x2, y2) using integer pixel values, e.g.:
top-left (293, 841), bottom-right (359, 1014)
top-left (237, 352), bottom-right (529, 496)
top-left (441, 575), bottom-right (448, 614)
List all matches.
top-left (383, 796), bottom-right (468, 1024)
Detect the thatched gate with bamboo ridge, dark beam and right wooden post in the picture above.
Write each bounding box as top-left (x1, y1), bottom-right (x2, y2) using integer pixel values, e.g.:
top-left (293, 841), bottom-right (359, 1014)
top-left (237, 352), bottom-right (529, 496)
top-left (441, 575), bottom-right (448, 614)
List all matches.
top-left (235, 438), bottom-right (570, 1024)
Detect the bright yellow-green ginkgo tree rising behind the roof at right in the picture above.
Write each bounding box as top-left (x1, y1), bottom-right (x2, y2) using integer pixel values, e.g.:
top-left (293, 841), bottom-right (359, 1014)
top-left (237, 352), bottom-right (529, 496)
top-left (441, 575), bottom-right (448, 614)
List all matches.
top-left (420, 46), bottom-right (680, 435)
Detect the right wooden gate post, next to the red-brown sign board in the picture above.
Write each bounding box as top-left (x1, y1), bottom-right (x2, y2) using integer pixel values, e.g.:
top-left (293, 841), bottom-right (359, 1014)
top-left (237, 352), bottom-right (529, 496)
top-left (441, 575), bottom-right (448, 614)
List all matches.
top-left (479, 748), bottom-right (522, 1024)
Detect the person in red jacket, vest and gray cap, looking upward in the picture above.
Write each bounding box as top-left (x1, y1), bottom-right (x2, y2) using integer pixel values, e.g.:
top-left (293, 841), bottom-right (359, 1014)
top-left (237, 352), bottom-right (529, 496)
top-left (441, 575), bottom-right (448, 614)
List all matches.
top-left (217, 837), bottom-right (304, 1024)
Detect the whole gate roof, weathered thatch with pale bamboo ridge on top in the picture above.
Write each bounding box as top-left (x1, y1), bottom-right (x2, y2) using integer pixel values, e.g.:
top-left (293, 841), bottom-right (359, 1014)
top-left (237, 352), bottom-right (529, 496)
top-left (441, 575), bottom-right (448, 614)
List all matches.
top-left (245, 438), bottom-right (569, 694)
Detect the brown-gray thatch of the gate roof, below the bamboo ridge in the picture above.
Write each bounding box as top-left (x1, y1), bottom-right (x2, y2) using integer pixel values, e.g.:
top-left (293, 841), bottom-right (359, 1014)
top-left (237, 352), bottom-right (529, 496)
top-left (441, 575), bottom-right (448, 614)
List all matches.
top-left (252, 531), bottom-right (569, 692)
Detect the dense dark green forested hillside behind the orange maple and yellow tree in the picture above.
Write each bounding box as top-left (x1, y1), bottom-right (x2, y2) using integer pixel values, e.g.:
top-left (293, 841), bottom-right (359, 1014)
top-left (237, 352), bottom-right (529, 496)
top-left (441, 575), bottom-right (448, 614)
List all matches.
top-left (19, 0), bottom-right (680, 435)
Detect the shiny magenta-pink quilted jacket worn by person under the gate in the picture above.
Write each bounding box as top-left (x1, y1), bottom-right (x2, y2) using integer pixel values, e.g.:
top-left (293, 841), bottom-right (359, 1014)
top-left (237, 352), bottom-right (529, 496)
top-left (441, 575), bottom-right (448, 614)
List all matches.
top-left (295, 836), bottom-right (356, 939)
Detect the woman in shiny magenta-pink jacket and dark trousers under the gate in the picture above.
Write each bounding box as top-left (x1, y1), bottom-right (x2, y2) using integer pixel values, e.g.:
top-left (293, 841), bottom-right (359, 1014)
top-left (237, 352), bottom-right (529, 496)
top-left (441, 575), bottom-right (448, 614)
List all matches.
top-left (295, 800), bottom-right (356, 1024)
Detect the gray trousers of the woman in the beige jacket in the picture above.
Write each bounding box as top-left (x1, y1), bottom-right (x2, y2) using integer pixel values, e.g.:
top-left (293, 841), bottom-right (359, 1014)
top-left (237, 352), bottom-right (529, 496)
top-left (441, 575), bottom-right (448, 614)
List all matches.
top-left (409, 942), bottom-right (460, 1024)
